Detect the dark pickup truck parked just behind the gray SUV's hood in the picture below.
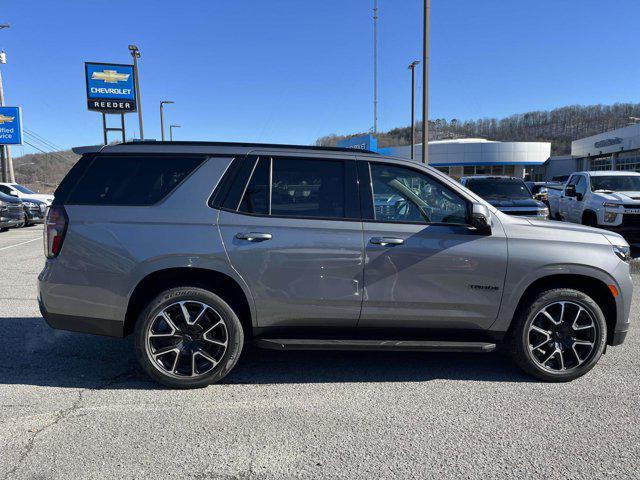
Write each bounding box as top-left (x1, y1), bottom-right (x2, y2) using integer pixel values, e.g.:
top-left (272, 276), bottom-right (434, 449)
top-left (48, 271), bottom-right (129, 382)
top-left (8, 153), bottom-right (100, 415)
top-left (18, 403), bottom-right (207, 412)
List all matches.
top-left (460, 176), bottom-right (549, 219)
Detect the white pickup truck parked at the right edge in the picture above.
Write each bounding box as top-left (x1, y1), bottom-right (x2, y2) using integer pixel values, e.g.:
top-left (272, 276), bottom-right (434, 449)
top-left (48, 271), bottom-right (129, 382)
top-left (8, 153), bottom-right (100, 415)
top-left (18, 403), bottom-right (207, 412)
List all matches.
top-left (547, 171), bottom-right (640, 243)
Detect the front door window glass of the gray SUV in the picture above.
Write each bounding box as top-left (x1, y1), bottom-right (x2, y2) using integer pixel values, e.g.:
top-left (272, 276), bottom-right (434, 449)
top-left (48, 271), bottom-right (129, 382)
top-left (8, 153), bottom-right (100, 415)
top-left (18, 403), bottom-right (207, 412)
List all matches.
top-left (370, 163), bottom-right (467, 224)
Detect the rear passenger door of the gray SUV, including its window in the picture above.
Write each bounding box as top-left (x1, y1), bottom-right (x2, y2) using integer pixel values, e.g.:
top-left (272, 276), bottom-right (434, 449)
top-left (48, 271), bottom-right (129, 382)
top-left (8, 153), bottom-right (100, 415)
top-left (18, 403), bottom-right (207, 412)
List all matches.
top-left (219, 155), bottom-right (364, 327)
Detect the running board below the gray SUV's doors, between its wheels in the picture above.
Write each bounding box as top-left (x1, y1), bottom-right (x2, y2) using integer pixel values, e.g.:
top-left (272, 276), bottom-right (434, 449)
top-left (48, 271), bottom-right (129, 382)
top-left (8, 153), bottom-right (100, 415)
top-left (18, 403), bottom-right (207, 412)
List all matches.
top-left (253, 338), bottom-right (496, 352)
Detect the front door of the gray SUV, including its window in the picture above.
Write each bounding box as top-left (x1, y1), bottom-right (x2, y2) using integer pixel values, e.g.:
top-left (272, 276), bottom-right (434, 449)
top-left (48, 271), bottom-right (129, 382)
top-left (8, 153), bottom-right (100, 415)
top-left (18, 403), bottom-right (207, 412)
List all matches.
top-left (358, 162), bottom-right (507, 329)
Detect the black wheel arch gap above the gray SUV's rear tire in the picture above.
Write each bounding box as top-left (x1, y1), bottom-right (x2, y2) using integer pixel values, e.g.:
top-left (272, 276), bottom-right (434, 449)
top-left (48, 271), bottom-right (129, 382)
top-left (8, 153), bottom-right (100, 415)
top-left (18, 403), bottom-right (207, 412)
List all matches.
top-left (124, 267), bottom-right (254, 337)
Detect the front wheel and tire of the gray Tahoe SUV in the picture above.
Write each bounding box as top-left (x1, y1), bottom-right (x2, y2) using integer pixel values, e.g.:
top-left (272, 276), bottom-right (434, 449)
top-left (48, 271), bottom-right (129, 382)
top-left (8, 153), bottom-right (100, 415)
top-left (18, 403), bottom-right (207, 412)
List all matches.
top-left (507, 288), bottom-right (607, 382)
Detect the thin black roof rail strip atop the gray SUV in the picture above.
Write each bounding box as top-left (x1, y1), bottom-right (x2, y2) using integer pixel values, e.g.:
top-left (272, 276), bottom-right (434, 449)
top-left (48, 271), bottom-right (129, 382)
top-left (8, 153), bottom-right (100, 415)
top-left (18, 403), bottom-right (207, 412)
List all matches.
top-left (72, 140), bottom-right (376, 154)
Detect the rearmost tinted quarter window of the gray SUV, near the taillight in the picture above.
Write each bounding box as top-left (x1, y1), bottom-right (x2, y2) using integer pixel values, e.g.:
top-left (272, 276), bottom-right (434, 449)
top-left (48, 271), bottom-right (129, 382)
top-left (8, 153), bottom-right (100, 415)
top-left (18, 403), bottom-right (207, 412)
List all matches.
top-left (65, 155), bottom-right (204, 205)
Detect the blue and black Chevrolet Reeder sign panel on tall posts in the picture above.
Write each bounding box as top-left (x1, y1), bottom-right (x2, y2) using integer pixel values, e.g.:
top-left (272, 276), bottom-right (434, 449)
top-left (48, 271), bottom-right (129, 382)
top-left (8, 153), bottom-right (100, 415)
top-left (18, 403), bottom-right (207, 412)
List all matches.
top-left (84, 62), bottom-right (136, 113)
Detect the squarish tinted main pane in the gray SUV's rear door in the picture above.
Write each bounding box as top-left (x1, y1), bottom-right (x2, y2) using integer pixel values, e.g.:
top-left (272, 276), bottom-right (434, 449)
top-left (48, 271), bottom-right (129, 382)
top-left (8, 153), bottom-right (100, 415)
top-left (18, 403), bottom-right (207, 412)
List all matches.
top-left (271, 158), bottom-right (346, 218)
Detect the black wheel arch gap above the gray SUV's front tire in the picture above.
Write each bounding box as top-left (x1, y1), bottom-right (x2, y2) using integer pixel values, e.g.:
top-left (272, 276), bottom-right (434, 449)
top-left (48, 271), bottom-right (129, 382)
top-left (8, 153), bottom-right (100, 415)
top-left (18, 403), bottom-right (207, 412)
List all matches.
top-left (511, 273), bottom-right (618, 345)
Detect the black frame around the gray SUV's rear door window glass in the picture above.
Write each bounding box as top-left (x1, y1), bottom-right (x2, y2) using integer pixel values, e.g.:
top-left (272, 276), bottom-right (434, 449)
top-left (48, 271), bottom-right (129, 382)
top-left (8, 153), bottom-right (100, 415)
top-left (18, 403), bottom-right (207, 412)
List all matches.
top-left (219, 154), bottom-right (363, 222)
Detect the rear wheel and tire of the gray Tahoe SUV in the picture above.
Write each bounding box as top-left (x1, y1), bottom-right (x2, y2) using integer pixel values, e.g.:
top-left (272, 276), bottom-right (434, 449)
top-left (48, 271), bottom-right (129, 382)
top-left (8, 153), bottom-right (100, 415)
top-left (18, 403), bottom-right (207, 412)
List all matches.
top-left (134, 287), bottom-right (244, 389)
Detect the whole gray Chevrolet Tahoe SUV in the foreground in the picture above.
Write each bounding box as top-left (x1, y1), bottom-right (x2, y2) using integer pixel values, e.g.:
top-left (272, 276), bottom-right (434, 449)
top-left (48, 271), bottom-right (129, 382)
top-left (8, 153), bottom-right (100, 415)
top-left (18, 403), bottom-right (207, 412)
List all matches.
top-left (38, 142), bottom-right (632, 388)
